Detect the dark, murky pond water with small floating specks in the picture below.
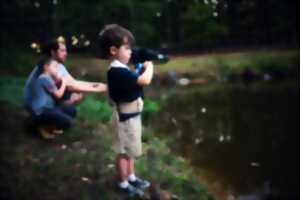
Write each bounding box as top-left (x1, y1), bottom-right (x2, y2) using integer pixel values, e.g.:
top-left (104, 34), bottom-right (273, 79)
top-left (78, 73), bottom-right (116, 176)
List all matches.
top-left (150, 81), bottom-right (300, 200)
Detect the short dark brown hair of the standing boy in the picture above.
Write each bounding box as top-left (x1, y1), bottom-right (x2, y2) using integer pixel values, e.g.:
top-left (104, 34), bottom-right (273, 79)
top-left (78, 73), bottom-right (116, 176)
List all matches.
top-left (99, 24), bottom-right (134, 59)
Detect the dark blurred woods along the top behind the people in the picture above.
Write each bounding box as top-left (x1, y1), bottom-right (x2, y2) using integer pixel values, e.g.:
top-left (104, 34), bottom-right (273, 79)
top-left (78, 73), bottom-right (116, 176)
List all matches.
top-left (0, 0), bottom-right (299, 56)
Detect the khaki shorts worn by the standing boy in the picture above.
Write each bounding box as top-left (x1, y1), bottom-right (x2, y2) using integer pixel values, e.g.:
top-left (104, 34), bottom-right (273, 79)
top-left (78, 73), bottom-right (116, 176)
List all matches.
top-left (112, 110), bottom-right (142, 158)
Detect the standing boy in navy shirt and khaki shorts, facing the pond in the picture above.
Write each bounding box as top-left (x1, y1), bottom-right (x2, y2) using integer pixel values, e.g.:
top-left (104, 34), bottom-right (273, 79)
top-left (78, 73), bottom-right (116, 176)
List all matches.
top-left (100, 24), bottom-right (153, 196)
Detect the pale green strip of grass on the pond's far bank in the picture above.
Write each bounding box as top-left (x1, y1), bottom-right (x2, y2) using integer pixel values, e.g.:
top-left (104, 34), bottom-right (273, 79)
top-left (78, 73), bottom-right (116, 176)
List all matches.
top-left (157, 50), bottom-right (299, 76)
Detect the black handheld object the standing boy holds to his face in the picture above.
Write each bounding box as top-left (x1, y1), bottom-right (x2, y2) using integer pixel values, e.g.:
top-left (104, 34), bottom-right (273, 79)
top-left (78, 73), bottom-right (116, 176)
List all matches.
top-left (131, 48), bottom-right (169, 73)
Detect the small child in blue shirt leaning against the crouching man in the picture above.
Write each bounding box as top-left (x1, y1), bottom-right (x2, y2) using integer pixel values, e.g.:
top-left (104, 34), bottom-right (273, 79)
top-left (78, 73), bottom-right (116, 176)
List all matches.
top-left (25, 58), bottom-right (75, 139)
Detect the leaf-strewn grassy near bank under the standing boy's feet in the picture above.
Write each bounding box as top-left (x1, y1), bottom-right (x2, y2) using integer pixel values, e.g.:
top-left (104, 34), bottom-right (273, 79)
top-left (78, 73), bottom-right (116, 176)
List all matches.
top-left (0, 76), bottom-right (214, 200)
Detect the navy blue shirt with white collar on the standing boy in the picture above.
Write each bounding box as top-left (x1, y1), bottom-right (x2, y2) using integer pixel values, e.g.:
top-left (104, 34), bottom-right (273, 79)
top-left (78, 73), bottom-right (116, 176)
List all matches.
top-left (107, 60), bottom-right (143, 121)
